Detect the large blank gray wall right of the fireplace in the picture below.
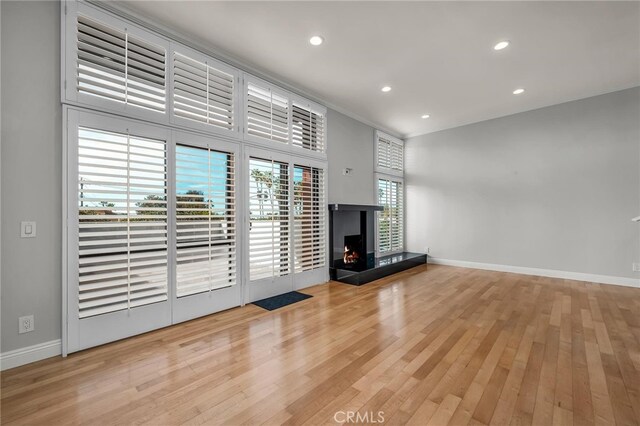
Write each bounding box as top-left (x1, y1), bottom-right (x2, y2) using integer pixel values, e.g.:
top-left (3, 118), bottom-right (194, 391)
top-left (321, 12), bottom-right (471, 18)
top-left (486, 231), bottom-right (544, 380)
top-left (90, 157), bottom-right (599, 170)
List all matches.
top-left (405, 88), bottom-right (640, 278)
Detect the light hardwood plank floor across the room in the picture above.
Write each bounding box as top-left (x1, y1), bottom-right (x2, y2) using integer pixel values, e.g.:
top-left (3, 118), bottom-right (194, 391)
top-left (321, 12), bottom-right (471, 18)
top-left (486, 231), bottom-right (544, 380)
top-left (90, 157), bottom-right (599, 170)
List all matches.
top-left (1, 265), bottom-right (640, 425)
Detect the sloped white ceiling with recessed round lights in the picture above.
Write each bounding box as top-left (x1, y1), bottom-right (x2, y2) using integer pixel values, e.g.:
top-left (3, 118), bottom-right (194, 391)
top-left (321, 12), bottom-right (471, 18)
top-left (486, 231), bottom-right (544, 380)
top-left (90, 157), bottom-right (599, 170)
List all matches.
top-left (112, 1), bottom-right (640, 136)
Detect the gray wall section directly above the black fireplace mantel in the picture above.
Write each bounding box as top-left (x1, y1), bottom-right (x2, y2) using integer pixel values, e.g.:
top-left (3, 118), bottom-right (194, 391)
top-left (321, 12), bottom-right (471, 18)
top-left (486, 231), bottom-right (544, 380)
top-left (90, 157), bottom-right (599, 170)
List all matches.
top-left (327, 110), bottom-right (377, 204)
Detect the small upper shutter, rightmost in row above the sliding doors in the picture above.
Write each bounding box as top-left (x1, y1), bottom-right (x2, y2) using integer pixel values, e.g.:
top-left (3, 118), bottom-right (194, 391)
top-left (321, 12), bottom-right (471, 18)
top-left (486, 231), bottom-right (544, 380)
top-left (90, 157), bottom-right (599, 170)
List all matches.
top-left (291, 102), bottom-right (325, 152)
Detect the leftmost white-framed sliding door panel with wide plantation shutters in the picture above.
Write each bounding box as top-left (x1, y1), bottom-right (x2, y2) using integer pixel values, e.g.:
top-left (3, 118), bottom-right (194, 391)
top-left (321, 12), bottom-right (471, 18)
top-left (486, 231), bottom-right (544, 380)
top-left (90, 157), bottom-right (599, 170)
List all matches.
top-left (67, 111), bottom-right (170, 352)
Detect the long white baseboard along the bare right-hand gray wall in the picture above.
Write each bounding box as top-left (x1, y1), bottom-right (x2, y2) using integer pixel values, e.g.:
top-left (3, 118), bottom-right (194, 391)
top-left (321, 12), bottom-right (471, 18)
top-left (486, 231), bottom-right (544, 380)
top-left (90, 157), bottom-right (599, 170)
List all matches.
top-left (427, 257), bottom-right (640, 288)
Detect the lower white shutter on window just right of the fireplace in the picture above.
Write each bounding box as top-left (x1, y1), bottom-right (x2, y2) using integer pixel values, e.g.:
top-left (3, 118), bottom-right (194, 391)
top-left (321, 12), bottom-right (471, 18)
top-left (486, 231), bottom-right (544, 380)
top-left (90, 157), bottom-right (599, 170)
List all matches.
top-left (377, 178), bottom-right (404, 253)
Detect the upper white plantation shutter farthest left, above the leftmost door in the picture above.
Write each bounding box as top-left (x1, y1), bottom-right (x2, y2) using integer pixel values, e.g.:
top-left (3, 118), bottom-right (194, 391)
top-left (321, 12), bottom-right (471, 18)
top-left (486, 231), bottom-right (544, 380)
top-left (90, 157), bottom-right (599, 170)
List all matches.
top-left (76, 14), bottom-right (166, 113)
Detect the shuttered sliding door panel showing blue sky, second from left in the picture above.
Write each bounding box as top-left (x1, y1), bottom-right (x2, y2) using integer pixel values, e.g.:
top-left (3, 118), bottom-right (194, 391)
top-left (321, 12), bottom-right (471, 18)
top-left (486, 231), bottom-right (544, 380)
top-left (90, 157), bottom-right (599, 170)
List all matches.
top-left (173, 134), bottom-right (241, 322)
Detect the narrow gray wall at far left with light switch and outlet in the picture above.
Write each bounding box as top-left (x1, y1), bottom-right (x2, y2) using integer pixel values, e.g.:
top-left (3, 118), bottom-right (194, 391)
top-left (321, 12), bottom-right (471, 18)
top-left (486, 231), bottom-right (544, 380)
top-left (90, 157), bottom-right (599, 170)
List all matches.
top-left (0, 1), bottom-right (62, 352)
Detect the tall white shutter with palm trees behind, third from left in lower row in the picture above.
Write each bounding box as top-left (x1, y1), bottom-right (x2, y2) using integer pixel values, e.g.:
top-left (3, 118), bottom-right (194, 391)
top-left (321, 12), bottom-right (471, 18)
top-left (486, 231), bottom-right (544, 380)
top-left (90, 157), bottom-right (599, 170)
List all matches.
top-left (249, 157), bottom-right (291, 281)
